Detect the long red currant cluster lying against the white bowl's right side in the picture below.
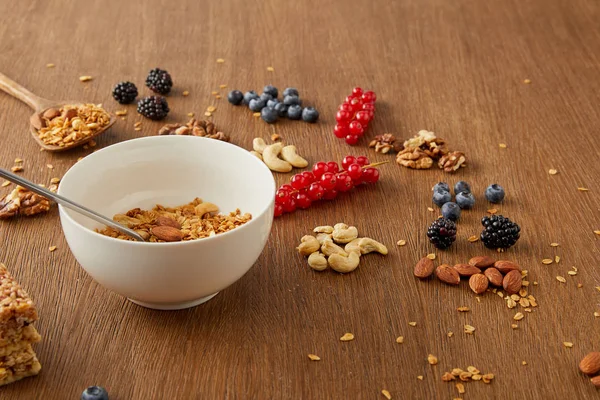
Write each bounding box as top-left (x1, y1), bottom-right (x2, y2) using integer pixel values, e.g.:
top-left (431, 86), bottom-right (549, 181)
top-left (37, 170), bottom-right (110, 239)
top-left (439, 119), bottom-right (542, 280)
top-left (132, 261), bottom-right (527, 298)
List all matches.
top-left (275, 156), bottom-right (380, 217)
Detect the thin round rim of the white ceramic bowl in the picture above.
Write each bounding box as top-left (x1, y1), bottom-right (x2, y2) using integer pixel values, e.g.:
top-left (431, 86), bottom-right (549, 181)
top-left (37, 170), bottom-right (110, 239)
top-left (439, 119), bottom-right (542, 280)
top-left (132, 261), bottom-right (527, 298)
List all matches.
top-left (57, 135), bottom-right (276, 247)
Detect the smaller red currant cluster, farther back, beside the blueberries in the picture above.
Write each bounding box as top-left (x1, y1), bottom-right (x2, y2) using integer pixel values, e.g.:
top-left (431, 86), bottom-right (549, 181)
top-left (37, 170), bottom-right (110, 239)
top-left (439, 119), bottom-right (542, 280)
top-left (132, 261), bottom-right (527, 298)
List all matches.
top-left (333, 87), bottom-right (377, 146)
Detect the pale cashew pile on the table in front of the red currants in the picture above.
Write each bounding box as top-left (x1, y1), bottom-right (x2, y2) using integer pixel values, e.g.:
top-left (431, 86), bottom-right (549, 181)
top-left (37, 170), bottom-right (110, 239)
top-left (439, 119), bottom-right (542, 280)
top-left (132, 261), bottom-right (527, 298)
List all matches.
top-left (297, 223), bottom-right (388, 274)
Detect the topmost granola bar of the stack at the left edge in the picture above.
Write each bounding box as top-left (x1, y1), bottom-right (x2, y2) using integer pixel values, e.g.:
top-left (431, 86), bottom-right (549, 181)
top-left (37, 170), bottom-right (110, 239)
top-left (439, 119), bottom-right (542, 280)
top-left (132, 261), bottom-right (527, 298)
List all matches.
top-left (0, 263), bottom-right (38, 332)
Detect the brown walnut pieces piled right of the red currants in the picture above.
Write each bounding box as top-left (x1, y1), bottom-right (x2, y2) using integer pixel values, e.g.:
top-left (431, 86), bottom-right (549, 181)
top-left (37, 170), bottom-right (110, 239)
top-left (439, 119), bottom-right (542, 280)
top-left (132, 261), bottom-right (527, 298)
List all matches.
top-left (396, 130), bottom-right (467, 172)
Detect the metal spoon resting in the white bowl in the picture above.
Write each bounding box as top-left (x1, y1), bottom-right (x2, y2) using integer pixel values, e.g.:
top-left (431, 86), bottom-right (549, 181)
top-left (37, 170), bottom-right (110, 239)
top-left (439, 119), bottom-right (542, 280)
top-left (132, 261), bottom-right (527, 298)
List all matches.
top-left (0, 168), bottom-right (145, 242)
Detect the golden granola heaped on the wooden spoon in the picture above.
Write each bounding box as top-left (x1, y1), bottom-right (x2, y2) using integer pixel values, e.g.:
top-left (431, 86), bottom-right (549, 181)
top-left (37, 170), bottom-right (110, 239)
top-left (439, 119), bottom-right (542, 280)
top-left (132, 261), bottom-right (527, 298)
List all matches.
top-left (30, 104), bottom-right (110, 147)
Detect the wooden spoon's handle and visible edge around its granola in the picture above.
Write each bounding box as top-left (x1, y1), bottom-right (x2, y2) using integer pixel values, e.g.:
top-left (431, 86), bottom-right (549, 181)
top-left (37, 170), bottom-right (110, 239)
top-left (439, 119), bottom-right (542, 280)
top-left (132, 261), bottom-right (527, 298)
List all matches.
top-left (0, 73), bottom-right (116, 151)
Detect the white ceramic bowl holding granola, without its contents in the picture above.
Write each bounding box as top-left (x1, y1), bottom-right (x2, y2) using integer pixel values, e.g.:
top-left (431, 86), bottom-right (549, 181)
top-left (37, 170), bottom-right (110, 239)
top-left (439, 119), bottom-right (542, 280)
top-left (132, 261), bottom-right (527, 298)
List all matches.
top-left (58, 136), bottom-right (275, 310)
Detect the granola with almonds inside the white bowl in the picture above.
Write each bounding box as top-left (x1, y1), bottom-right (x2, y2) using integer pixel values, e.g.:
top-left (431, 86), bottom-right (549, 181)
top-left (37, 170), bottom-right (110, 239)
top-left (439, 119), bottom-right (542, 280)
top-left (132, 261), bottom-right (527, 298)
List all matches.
top-left (97, 198), bottom-right (252, 242)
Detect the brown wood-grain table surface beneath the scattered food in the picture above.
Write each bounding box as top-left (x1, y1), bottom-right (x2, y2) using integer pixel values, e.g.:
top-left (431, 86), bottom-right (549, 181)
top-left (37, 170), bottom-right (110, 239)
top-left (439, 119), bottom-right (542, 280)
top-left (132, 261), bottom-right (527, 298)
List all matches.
top-left (0, 0), bottom-right (600, 400)
